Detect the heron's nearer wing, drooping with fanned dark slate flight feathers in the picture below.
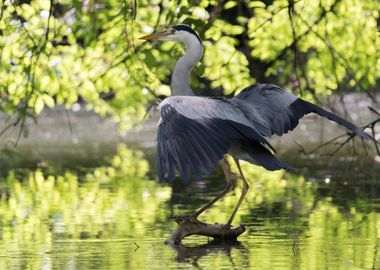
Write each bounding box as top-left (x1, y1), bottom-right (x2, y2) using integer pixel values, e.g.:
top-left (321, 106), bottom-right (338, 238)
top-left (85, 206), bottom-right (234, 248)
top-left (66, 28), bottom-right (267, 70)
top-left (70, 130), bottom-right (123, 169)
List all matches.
top-left (157, 96), bottom-right (271, 181)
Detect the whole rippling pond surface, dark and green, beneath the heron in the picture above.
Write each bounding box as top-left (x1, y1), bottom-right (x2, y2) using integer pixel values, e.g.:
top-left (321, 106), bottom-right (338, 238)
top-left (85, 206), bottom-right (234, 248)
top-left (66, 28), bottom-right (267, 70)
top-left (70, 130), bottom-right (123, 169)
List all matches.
top-left (0, 100), bottom-right (380, 269)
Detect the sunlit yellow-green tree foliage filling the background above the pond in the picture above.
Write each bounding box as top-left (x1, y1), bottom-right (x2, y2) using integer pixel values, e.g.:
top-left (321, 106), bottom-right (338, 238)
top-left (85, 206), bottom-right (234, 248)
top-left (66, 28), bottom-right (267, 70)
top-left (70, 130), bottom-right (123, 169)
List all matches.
top-left (0, 0), bottom-right (380, 132)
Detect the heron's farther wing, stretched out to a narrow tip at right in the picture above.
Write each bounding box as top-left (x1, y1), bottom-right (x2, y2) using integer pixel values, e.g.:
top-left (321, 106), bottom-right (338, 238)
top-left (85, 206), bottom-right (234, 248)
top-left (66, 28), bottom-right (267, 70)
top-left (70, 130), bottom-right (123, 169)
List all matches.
top-left (230, 84), bottom-right (374, 140)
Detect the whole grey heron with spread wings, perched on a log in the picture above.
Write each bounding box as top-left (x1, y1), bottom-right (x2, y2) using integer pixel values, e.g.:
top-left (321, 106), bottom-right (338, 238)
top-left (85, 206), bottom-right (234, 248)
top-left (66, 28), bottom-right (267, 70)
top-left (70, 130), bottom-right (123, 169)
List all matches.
top-left (141, 24), bottom-right (374, 226)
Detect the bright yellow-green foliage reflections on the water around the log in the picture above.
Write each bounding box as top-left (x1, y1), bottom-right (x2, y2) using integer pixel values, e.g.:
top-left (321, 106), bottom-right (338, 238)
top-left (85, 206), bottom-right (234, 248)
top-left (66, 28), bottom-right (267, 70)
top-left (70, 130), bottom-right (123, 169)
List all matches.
top-left (0, 146), bottom-right (380, 269)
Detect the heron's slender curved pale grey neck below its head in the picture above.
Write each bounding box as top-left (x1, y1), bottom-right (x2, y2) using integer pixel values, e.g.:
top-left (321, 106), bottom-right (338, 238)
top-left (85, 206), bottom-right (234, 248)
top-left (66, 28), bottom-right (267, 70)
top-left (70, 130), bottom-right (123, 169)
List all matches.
top-left (171, 34), bottom-right (203, 96)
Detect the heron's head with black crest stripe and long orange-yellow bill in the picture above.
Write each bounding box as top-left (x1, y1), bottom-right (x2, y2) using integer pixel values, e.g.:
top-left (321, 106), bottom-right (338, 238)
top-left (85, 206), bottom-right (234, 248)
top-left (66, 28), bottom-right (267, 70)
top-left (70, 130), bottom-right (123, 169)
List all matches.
top-left (140, 24), bottom-right (202, 45)
